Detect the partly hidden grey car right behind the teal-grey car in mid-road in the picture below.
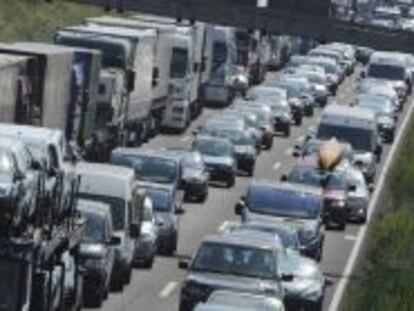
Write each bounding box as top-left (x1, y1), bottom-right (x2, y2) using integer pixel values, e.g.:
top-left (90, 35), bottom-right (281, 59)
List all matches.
top-left (211, 130), bottom-right (257, 176)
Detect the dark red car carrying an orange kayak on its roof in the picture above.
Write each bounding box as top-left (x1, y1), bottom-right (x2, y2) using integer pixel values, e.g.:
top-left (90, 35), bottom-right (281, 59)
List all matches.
top-left (282, 161), bottom-right (351, 230)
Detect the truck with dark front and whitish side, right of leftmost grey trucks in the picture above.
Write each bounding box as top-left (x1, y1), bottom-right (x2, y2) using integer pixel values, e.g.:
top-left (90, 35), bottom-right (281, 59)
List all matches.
top-left (55, 25), bottom-right (157, 156)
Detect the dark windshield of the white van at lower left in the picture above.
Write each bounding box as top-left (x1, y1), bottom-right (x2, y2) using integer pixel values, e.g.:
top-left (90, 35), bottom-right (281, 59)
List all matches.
top-left (79, 193), bottom-right (126, 231)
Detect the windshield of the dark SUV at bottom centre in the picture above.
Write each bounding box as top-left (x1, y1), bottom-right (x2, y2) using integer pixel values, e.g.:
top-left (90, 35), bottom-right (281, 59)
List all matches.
top-left (191, 242), bottom-right (276, 279)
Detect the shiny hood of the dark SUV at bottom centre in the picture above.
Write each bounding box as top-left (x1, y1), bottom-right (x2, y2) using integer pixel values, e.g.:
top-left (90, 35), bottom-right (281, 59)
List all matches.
top-left (186, 271), bottom-right (280, 295)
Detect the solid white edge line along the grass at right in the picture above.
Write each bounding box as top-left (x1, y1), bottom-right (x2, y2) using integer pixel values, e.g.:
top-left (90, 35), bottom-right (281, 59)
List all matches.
top-left (328, 99), bottom-right (413, 311)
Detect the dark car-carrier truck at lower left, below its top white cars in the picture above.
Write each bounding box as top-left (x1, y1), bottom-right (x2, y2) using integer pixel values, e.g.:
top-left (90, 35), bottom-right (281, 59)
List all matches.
top-left (0, 143), bottom-right (84, 311)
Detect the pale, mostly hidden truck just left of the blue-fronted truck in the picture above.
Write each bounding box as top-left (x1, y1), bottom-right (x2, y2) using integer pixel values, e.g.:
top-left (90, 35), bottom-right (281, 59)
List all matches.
top-left (132, 14), bottom-right (212, 119)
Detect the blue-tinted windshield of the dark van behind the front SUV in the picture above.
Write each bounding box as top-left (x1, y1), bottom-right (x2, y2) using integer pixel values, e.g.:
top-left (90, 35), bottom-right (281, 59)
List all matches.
top-left (247, 187), bottom-right (321, 219)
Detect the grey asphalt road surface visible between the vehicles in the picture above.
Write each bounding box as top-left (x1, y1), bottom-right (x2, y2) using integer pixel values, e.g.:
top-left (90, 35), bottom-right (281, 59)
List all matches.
top-left (93, 67), bottom-right (408, 311)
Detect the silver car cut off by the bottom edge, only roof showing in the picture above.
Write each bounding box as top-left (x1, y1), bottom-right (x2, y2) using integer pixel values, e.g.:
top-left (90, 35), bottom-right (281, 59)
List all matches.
top-left (207, 290), bottom-right (285, 311)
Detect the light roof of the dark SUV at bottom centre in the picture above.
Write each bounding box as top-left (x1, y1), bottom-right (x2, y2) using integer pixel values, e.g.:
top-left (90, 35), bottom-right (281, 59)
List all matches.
top-left (203, 230), bottom-right (281, 250)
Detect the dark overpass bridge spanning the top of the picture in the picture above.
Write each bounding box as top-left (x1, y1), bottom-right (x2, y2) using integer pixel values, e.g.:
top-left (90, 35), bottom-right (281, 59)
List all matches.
top-left (68, 0), bottom-right (414, 53)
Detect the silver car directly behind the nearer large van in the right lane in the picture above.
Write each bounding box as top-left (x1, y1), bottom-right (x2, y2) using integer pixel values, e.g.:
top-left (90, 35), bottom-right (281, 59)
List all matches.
top-left (356, 94), bottom-right (397, 143)
